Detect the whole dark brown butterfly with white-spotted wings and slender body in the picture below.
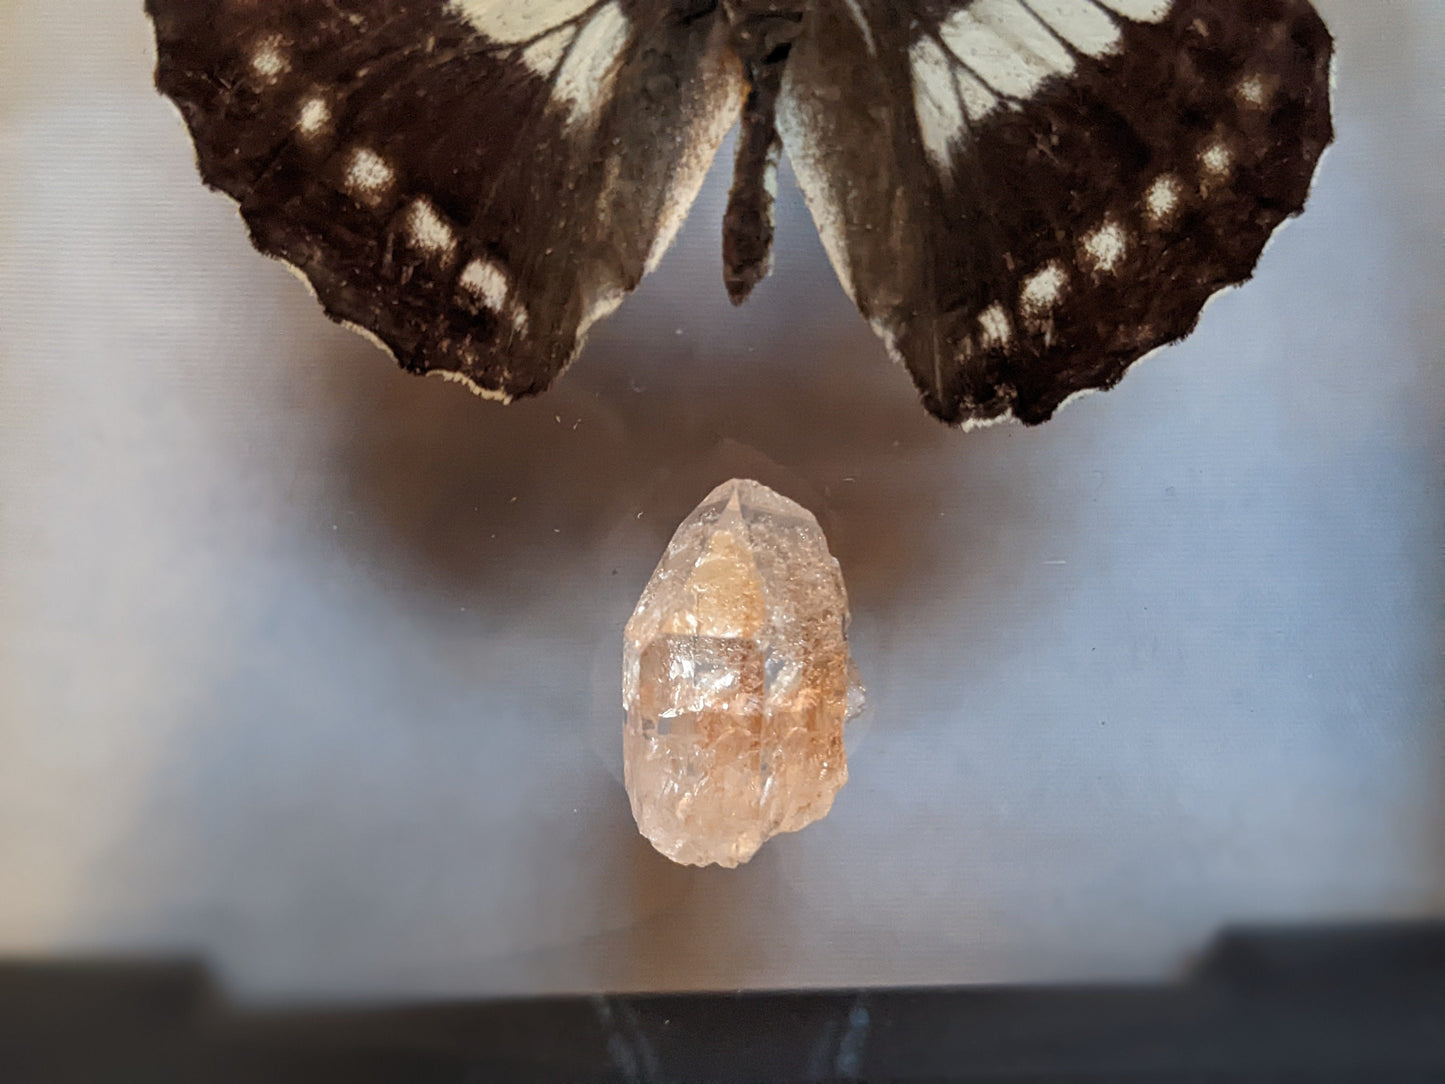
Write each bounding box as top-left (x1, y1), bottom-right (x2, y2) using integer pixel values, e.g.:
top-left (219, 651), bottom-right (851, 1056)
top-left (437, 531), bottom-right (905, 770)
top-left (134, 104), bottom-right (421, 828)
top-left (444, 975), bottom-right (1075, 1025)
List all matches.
top-left (146, 0), bottom-right (1332, 425)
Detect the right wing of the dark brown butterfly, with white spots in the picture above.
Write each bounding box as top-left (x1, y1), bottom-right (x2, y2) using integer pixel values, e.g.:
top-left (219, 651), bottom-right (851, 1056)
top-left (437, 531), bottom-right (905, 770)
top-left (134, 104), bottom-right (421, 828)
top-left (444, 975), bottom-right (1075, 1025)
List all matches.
top-left (779, 0), bottom-right (1332, 423)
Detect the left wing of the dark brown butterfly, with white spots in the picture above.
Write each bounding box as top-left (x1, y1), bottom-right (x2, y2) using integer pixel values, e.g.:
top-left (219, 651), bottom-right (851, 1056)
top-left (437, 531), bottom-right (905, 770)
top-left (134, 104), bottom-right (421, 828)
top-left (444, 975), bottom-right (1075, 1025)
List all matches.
top-left (147, 0), bottom-right (740, 399)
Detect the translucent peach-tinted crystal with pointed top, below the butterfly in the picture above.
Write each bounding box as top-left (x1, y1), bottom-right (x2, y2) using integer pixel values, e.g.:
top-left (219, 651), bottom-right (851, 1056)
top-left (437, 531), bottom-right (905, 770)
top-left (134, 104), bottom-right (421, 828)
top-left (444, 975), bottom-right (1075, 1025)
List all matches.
top-left (623, 478), bottom-right (863, 866)
